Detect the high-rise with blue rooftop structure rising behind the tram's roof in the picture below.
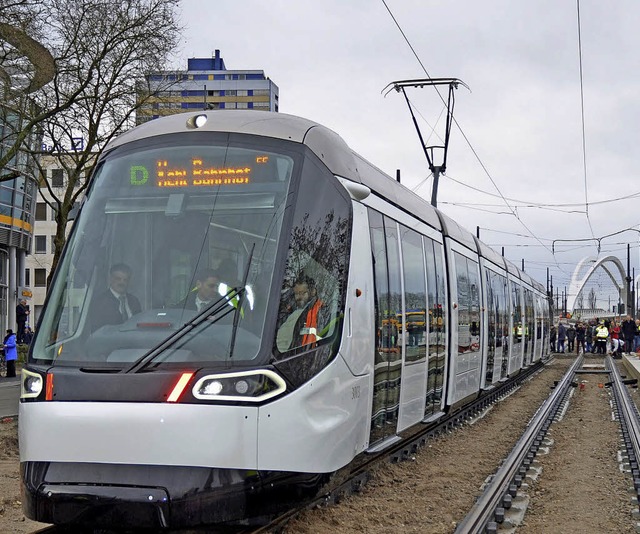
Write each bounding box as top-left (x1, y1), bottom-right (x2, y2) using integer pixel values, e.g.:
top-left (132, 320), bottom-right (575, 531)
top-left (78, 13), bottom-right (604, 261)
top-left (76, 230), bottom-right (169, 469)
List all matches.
top-left (136, 50), bottom-right (278, 124)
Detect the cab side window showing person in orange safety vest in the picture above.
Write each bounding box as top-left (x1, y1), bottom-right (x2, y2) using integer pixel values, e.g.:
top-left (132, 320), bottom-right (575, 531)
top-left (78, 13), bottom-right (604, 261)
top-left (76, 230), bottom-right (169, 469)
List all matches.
top-left (273, 156), bottom-right (351, 383)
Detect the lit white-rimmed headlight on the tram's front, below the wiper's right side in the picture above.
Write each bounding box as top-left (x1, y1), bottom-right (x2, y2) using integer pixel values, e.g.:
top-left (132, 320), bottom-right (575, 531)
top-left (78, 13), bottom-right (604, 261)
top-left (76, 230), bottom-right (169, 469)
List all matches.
top-left (192, 369), bottom-right (287, 402)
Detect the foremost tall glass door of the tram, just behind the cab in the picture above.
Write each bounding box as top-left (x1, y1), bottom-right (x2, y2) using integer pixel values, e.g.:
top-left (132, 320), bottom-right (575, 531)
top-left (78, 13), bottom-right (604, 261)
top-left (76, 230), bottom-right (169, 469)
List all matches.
top-left (369, 209), bottom-right (402, 446)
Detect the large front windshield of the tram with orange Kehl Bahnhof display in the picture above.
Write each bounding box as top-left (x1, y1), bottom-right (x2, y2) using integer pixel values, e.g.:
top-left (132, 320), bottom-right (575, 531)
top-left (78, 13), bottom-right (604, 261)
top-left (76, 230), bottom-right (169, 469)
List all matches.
top-left (31, 133), bottom-right (304, 368)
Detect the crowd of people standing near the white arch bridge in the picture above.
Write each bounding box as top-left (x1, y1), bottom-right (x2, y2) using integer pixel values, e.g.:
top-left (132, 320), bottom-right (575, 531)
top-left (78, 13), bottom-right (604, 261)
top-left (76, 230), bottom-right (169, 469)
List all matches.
top-left (549, 315), bottom-right (640, 357)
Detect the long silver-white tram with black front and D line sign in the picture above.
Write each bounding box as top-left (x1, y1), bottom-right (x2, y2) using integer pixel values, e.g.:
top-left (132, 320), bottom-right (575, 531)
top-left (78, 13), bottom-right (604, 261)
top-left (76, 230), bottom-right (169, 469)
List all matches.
top-left (19, 110), bottom-right (550, 529)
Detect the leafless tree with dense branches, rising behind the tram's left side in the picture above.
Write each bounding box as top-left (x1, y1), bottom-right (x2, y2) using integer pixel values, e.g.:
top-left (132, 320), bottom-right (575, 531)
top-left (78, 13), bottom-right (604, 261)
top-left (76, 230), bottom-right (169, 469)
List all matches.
top-left (0, 0), bottom-right (182, 282)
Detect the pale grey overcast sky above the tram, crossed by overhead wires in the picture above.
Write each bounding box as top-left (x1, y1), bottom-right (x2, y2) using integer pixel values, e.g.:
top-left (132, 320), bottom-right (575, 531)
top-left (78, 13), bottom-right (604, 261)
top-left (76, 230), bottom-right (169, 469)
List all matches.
top-left (176, 0), bottom-right (640, 312)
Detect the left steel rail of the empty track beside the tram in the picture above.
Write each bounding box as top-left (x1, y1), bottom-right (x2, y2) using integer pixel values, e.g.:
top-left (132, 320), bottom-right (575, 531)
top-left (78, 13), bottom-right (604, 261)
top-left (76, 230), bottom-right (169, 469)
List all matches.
top-left (455, 356), bottom-right (584, 534)
